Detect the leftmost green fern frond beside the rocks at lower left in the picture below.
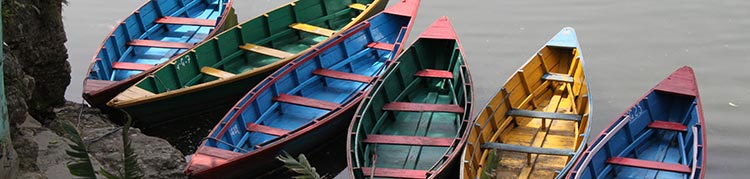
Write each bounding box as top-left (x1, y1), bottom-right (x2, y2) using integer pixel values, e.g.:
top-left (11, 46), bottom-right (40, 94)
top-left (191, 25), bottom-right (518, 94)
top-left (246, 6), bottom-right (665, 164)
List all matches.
top-left (60, 121), bottom-right (96, 179)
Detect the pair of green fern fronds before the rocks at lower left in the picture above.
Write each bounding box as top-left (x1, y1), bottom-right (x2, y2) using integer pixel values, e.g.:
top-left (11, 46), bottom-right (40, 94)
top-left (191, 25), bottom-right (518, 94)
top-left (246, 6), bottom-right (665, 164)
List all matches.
top-left (61, 116), bottom-right (143, 179)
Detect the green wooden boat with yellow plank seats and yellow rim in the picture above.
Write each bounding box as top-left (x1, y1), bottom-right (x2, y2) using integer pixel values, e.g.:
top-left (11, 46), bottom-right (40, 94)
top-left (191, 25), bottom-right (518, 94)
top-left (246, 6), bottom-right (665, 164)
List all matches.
top-left (107, 0), bottom-right (388, 127)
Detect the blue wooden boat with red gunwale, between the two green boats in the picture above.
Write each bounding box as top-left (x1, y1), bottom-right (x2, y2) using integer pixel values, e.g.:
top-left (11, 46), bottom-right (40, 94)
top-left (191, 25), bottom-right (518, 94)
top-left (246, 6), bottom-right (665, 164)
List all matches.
top-left (185, 0), bottom-right (419, 178)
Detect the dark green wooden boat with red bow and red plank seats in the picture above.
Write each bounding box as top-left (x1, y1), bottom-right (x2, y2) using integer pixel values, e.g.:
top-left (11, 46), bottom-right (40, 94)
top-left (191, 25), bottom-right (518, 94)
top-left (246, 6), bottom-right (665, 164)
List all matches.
top-left (347, 17), bottom-right (474, 178)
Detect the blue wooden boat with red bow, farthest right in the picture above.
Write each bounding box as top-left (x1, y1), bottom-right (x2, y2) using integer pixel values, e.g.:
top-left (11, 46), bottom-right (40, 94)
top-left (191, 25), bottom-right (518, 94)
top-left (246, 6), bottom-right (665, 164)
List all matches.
top-left (567, 66), bottom-right (706, 179)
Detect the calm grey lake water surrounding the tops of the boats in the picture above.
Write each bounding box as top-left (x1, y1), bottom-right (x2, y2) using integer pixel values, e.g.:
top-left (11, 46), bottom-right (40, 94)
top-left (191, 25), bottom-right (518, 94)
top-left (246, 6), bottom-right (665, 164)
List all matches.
top-left (63, 0), bottom-right (750, 178)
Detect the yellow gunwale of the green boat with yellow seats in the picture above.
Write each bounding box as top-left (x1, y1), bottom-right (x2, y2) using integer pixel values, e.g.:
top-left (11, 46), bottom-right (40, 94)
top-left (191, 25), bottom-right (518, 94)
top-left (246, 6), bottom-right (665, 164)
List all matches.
top-left (107, 0), bottom-right (388, 108)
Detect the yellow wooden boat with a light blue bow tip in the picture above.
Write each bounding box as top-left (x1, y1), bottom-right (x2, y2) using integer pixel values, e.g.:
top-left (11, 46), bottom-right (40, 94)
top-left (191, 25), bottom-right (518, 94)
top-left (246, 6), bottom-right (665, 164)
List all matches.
top-left (461, 27), bottom-right (591, 179)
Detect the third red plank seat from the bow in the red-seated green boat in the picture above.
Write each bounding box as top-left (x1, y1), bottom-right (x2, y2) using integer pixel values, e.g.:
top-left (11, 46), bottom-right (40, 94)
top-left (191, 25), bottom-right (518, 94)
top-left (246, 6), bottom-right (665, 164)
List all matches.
top-left (362, 134), bottom-right (455, 147)
